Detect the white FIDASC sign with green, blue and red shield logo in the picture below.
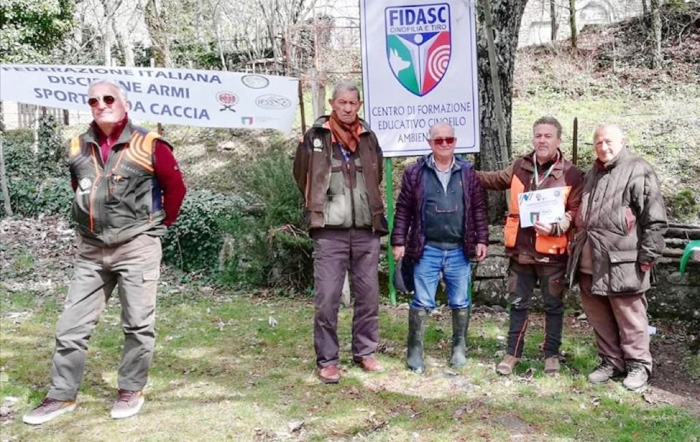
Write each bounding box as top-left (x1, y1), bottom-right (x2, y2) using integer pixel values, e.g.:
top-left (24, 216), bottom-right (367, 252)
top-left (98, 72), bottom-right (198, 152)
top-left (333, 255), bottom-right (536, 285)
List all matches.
top-left (360, 0), bottom-right (479, 157)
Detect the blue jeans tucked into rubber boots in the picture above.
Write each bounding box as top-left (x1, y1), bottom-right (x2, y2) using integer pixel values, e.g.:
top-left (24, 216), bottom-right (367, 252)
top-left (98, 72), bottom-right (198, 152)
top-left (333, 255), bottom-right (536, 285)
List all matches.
top-left (411, 246), bottom-right (472, 310)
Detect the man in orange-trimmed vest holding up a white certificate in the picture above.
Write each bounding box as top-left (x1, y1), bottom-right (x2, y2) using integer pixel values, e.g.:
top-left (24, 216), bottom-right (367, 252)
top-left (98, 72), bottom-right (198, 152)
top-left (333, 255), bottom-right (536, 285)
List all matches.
top-left (477, 117), bottom-right (583, 375)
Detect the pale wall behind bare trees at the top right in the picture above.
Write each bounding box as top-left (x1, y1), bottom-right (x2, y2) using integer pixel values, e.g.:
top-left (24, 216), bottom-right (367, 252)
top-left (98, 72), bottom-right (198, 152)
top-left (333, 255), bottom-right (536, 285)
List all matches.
top-left (518, 0), bottom-right (648, 47)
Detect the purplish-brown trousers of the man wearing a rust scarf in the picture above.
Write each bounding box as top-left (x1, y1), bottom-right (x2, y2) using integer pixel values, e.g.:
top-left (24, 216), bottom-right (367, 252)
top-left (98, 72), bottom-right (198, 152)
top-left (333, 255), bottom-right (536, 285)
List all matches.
top-left (311, 228), bottom-right (379, 367)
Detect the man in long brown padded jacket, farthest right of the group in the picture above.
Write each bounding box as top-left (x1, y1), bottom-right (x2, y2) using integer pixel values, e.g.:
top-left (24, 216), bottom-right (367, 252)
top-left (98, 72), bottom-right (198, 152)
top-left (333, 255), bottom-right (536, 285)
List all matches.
top-left (569, 125), bottom-right (668, 391)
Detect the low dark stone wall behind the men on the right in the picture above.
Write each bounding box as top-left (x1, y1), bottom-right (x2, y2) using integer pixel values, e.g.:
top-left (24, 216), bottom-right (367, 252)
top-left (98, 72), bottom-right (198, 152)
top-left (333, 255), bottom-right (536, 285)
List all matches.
top-left (474, 225), bottom-right (700, 320)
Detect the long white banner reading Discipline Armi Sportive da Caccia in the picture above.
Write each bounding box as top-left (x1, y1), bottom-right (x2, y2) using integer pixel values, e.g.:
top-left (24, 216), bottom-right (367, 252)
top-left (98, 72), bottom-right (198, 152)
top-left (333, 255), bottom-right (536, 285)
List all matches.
top-left (0, 64), bottom-right (298, 132)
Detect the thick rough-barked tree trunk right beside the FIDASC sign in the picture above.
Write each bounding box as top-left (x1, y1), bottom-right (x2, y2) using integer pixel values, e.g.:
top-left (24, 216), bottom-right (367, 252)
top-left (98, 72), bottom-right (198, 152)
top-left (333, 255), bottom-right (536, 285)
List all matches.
top-left (477, 0), bottom-right (527, 223)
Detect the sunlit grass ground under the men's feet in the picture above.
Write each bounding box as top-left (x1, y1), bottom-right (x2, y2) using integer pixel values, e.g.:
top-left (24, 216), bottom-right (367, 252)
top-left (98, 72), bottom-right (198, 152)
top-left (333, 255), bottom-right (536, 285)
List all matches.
top-left (0, 286), bottom-right (700, 441)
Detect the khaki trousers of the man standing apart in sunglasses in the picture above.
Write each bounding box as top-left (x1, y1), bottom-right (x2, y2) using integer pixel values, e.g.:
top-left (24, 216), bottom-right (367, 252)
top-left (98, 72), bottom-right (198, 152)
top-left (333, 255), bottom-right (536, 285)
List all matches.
top-left (47, 235), bottom-right (161, 400)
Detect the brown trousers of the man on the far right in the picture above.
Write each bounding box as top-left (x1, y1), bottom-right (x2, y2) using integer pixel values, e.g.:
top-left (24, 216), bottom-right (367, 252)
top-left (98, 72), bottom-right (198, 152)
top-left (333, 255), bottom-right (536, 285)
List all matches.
top-left (579, 273), bottom-right (652, 374)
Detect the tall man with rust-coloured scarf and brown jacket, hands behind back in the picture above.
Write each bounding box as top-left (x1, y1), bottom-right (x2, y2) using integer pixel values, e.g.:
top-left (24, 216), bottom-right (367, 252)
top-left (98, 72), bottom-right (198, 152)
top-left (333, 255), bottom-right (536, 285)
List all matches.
top-left (294, 84), bottom-right (388, 384)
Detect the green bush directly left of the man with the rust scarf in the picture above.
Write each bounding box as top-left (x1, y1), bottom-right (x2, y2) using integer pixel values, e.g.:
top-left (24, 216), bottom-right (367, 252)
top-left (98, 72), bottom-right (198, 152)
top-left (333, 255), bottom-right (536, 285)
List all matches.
top-left (215, 139), bottom-right (313, 290)
